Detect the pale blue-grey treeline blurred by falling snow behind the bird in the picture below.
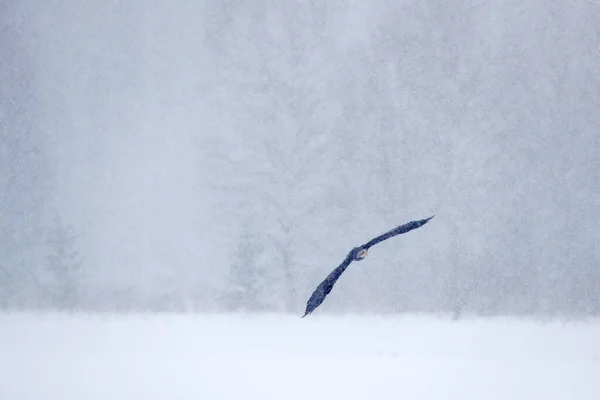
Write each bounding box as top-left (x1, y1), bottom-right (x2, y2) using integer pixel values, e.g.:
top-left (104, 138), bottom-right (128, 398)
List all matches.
top-left (0, 0), bottom-right (600, 316)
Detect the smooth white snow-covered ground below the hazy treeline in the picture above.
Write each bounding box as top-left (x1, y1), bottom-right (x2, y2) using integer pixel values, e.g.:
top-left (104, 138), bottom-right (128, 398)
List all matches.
top-left (0, 314), bottom-right (600, 400)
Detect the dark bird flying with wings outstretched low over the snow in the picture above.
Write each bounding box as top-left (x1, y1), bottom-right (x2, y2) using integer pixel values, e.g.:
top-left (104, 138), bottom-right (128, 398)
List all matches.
top-left (302, 215), bottom-right (434, 318)
